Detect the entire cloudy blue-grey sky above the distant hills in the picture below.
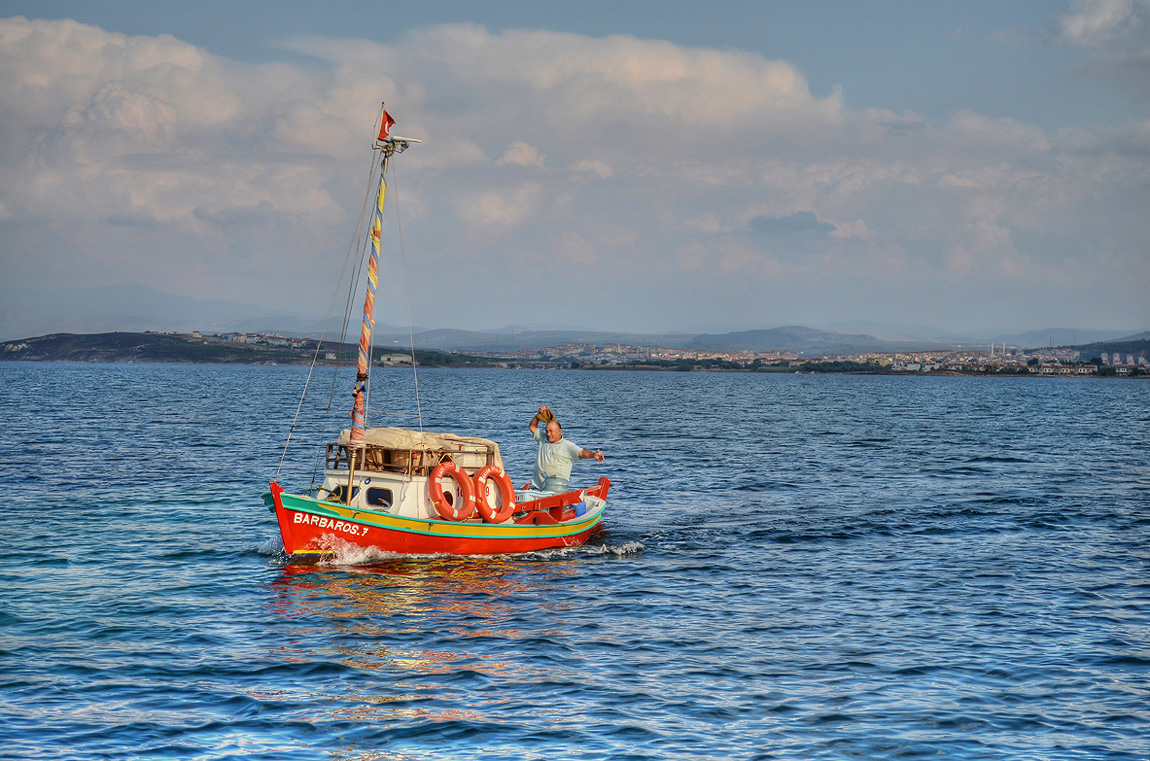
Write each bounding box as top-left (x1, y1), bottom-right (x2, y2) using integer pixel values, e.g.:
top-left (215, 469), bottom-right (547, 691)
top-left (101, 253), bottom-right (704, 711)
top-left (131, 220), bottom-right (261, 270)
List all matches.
top-left (0, 0), bottom-right (1150, 332)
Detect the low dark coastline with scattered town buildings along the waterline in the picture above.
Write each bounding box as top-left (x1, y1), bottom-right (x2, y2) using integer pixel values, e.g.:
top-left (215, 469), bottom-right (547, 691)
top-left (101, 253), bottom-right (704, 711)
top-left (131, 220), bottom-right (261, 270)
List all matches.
top-left (0, 331), bottom-right (1150, 377)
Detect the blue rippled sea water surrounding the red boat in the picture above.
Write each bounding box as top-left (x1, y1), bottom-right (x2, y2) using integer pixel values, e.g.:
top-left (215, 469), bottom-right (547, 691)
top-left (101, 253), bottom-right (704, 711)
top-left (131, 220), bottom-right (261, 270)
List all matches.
top-left (0, 363), bottom-right (1150, 760)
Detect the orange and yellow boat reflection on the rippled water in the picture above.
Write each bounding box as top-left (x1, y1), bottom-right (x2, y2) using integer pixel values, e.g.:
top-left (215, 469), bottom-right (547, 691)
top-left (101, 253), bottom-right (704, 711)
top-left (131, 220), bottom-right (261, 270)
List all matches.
top-left (261, 558), bottom-right (580, 761)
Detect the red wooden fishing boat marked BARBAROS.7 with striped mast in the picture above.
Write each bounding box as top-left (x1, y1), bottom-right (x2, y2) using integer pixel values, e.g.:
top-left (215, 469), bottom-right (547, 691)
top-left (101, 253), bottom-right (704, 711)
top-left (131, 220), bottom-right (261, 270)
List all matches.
top-left (265, 107), bottom-right (611, 561)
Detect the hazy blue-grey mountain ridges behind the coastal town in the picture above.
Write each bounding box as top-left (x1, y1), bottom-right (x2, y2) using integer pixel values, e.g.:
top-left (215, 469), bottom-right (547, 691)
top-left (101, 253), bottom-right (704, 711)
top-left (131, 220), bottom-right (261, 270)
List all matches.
top-left (0, 285), bottom-right (1132, 355)
